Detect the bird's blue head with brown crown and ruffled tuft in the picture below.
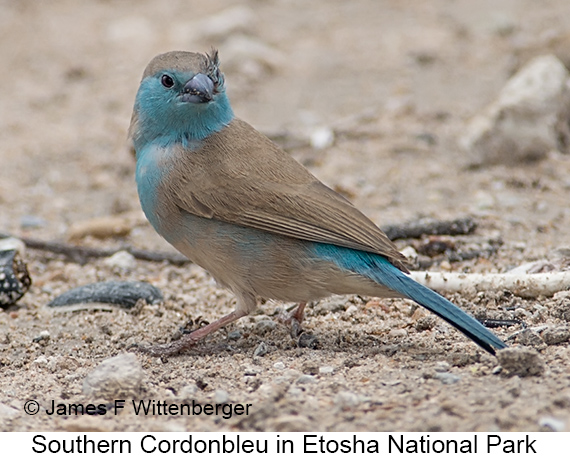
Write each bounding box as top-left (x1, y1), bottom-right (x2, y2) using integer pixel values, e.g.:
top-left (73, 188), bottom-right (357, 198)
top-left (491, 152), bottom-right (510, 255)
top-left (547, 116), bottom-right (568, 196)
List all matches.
top-left (129, 50), bottom-right (233, 150)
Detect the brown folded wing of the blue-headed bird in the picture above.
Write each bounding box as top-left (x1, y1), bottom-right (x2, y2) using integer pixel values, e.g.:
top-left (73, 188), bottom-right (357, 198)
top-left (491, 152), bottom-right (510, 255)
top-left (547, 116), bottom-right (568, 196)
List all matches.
top-left (170, 119), bottom-right (407, 271)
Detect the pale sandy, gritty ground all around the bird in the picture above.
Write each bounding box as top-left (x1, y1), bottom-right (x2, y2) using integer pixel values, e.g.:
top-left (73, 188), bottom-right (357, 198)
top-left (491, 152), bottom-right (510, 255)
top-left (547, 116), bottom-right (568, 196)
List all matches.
top-left (0, 0), bottom-right (570, 431)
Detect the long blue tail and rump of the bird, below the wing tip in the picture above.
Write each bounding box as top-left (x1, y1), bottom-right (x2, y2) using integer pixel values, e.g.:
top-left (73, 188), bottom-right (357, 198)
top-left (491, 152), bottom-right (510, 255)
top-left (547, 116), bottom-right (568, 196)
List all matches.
top-left (315, 243), bottom-right (507, 355)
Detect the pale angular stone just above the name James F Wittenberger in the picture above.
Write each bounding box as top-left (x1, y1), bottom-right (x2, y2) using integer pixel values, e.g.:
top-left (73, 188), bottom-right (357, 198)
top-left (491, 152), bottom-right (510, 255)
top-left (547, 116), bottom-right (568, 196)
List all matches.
top-left (83, 354), bottom-right (144, 400)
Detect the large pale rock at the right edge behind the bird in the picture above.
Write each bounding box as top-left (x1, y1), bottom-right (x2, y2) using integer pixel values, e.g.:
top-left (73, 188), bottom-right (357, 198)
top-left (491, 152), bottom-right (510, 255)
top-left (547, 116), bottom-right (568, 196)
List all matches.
top-left (460, 55), bottom-right (570, 166)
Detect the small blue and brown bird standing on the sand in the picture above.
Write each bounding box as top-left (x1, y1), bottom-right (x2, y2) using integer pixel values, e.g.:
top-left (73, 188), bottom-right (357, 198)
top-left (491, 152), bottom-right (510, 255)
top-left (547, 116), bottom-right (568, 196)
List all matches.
top-left (129, 49), bottom-right (506, 356)
